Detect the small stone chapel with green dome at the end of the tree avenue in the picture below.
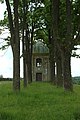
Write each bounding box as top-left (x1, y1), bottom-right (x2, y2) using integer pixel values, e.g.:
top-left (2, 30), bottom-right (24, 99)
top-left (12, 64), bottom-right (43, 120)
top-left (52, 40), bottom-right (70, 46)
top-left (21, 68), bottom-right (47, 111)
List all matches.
top-left (32, 40), bottom-right (50, 81)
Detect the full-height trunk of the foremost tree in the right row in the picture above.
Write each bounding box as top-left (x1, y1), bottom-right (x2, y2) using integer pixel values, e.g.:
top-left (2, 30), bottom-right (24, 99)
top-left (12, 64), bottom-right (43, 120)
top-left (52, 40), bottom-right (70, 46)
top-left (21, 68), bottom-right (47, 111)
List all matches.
top-left (63, 0), bottom-right (73, 91)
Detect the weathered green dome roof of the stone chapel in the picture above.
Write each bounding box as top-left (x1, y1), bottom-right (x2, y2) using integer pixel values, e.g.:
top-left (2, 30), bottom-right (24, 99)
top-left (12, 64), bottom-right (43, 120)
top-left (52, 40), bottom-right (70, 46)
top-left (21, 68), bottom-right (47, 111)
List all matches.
top-left (33, 40), bottom-right (49, 53)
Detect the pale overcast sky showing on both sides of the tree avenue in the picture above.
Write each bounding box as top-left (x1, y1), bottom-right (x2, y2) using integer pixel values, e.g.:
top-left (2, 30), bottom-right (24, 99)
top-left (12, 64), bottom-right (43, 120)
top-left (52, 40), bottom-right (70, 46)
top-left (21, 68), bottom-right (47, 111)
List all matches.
top-left (0, 4), bottom-right (80, 78)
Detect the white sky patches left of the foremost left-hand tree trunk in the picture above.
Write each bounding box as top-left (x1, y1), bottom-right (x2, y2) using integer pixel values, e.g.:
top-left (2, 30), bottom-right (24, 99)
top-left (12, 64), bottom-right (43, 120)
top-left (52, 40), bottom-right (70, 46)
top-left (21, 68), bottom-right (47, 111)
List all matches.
top-left (0, 4), bottom-right (13, 77)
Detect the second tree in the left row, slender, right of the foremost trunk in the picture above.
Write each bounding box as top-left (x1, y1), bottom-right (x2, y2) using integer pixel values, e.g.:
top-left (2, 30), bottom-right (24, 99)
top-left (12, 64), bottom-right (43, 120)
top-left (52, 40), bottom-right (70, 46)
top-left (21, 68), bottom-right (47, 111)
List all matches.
top-left (20, 0), bottom-right (29, 87)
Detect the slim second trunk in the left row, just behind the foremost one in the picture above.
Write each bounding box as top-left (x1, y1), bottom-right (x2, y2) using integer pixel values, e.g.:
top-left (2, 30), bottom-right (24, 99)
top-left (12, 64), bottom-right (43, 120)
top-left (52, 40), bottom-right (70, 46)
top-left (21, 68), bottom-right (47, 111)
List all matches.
top-left (22, 0), bottom-right (28, 87)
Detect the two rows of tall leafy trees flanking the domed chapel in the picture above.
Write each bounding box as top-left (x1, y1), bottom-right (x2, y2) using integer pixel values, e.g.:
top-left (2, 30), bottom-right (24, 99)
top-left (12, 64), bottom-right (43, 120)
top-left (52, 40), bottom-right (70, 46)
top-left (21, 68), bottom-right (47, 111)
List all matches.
top-left (0, 0), bottom-right (80, 91)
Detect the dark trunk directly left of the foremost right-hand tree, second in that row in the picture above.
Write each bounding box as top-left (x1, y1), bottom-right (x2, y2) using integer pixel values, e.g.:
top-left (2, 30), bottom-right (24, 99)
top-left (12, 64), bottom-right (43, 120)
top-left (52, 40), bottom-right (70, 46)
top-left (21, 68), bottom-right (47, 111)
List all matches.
top-left (51, 0), bottom-right (62, 86)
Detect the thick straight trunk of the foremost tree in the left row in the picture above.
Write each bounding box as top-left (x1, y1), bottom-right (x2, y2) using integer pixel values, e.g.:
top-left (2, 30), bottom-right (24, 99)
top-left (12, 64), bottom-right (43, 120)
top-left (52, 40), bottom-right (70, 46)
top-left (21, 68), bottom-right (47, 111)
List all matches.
top-left (13, 0), bottom-right (20, 90)
